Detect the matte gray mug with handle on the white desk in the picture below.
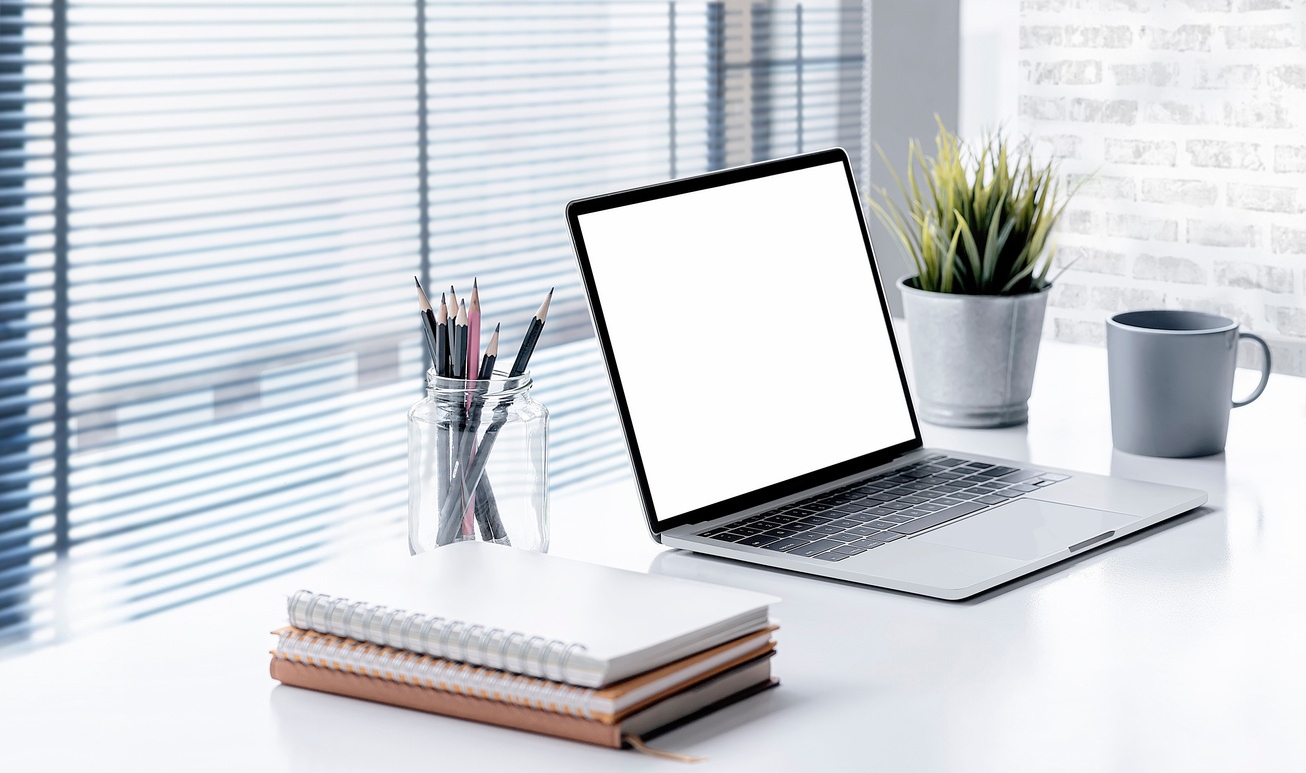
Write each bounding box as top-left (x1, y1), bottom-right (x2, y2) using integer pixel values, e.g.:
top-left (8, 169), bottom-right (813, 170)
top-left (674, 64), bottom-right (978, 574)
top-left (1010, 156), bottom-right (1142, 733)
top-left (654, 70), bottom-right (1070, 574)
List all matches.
top-left (1106, 311), bottom-right (1269, 457)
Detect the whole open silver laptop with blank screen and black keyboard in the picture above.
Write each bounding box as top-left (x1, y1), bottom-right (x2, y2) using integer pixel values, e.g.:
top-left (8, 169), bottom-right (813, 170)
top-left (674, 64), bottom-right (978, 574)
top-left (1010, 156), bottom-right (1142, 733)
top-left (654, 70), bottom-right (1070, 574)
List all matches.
top-left (567, 149), bottom-right (1207, 599)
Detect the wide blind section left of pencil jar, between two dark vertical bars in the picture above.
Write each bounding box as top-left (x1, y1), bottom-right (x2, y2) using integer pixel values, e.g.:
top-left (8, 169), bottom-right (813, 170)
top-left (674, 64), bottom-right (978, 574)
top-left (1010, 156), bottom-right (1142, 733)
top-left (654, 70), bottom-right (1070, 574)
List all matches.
top-left (3, 0), bottom-right (421, 640)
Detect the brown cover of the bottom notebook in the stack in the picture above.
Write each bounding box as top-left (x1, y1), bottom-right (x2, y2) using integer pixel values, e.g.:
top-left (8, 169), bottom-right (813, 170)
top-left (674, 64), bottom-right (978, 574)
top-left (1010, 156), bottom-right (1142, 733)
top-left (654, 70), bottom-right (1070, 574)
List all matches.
top-left (270, 650), bottom-right (774, 748)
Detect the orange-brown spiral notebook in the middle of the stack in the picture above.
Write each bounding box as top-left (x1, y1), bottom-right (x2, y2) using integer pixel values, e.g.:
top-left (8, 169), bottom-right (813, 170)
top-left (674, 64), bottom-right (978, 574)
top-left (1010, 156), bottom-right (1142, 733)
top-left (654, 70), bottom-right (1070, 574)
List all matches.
top-left (272, 627), bottom-right (776, 725)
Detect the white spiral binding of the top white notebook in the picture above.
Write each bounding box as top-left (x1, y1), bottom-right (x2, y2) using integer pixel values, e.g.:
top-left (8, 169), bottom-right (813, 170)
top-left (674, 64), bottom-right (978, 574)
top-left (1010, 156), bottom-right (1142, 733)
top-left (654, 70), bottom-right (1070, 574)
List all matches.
top-left (286, 590), bottom-right (585, 682)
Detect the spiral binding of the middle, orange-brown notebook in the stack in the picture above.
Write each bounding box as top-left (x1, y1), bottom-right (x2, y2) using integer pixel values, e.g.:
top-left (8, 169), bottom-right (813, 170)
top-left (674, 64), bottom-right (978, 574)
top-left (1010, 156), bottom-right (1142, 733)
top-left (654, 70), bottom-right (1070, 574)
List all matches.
top-left (276, 629), bottom-right (594, 719)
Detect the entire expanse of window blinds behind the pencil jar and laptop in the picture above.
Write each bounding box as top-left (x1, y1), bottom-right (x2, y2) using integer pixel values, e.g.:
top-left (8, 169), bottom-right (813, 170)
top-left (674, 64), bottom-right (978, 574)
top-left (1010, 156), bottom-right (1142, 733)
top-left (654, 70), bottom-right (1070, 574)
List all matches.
top-left (0, 0), bottom-right (865, 642)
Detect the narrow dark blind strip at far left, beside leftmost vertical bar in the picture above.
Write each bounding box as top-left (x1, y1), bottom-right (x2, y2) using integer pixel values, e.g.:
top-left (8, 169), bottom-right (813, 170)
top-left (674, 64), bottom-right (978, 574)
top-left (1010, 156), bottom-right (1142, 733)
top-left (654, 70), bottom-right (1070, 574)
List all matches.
top-left (0, 4), bottom-right (56, 641)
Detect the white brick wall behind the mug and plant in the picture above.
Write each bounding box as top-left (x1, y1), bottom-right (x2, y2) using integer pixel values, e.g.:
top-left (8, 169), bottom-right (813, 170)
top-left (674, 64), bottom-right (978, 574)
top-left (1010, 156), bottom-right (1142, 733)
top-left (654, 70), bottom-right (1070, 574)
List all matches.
top-left (1017, 0), bottom-right (1306, 375)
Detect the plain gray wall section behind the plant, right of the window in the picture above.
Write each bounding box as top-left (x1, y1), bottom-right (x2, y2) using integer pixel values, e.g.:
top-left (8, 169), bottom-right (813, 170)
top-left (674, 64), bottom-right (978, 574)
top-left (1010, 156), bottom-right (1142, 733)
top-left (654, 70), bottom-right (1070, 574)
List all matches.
top-left (865, 0), bottom-right (961, 316)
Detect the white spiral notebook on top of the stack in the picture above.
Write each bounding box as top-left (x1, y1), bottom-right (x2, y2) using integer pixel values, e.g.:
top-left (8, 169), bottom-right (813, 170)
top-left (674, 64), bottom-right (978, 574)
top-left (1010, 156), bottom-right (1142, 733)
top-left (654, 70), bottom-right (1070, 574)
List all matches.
top-left (287, 542), bottom-right (780, 687)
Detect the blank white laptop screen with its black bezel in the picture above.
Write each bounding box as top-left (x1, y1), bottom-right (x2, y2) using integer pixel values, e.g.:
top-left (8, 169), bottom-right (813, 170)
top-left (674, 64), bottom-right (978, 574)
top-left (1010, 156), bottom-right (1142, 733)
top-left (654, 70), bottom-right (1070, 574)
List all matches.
top-left (568, 150), bottom-right (917, 530)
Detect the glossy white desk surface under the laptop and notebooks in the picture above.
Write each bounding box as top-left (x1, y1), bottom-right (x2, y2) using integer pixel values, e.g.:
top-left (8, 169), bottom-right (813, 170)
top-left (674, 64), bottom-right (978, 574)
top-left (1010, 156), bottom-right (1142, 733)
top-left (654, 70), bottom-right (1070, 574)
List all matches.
top-left (0, 342), bottom-right (1306, 773)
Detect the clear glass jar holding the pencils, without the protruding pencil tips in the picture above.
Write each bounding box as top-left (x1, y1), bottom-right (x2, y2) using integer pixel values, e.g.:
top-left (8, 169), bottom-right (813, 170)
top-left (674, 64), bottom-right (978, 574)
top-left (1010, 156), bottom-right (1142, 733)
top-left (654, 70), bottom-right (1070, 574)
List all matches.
top-left (407, 370), bottom-right (549, 555)
